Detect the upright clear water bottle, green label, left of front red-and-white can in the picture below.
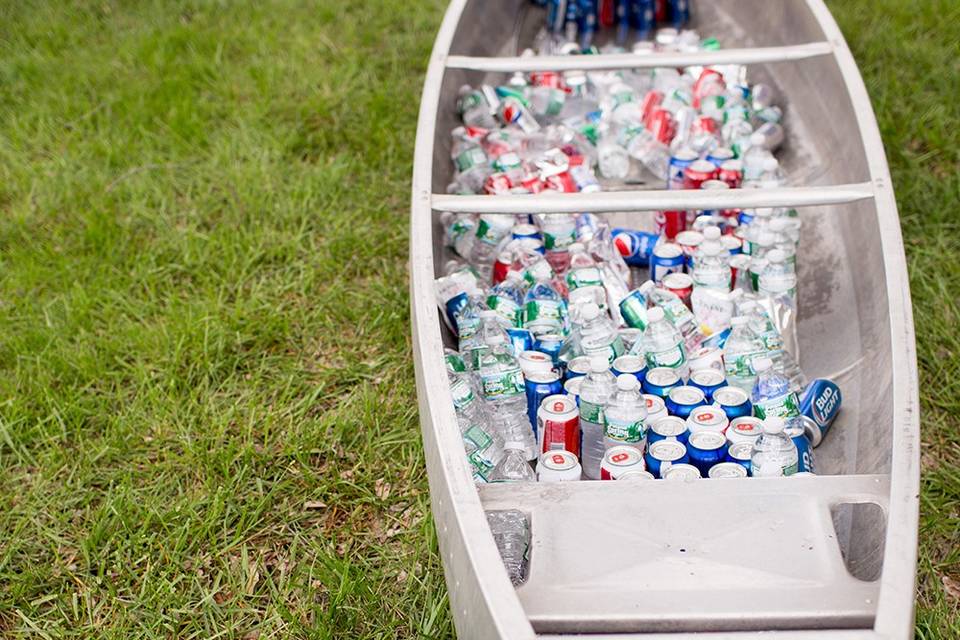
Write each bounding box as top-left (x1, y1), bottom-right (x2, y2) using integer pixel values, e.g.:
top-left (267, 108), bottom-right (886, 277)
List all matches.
top-left (478, 329), bottom-right (538, 460)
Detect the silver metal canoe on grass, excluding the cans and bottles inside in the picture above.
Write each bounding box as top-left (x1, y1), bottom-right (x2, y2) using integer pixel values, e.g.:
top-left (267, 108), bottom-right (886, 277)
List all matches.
top-left (410, 0), bottom-right (919, 639)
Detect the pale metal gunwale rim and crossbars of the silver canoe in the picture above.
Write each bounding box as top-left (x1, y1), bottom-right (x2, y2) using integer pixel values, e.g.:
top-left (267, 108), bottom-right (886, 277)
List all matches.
top-left (410, 0), bottom-right (919, 640)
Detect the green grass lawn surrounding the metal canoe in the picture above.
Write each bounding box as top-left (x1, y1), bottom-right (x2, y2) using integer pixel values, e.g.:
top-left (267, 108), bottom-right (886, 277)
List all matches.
top-left (0, 0), bottom-right (960, 638)
